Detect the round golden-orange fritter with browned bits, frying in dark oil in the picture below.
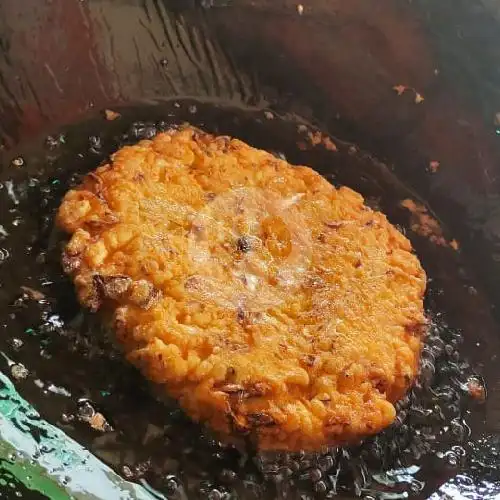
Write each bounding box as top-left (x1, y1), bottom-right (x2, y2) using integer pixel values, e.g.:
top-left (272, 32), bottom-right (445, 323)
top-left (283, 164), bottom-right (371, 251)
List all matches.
top-left (58, 124), bottom-right (426, 450)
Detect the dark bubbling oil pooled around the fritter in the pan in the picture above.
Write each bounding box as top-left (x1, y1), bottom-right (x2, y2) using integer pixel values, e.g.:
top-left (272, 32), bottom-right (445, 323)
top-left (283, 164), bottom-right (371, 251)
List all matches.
top-left (0, 100), bottom-right (500, 499)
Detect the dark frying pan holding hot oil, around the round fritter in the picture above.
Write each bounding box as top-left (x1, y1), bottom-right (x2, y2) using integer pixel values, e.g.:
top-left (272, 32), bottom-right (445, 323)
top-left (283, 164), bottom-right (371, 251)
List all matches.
top-left (0, 0), bottom-right (500, 500)
